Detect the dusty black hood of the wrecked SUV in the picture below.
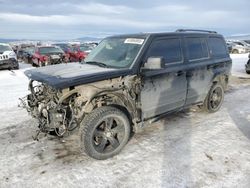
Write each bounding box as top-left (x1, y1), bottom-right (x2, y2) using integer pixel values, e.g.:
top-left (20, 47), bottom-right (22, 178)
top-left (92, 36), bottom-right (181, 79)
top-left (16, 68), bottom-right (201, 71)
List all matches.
top-left (24, 63), bottom-right (129, 89)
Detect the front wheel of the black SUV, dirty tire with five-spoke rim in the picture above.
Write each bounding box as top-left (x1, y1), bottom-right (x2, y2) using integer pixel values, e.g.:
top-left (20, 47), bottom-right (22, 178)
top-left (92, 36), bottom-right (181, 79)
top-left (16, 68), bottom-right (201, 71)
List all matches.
top-left (79, 106), bottom-right (131, 160)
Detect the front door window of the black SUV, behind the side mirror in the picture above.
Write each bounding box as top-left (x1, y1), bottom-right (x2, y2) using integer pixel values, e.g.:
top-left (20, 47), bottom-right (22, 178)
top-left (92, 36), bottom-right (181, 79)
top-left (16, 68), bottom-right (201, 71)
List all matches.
top-left (146, 38), bottom-right (182, 63)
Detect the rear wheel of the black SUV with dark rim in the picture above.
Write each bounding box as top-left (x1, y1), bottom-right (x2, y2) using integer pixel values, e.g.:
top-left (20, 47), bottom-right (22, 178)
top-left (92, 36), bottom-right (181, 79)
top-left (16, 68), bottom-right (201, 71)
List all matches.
top-left (203, 83), bottom-right (224, 113)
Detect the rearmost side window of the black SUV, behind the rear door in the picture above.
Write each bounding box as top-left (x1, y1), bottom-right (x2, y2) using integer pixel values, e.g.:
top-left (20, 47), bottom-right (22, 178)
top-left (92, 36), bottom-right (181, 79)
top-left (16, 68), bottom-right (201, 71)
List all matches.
top-left (208, 37), bottom-right (228, 57)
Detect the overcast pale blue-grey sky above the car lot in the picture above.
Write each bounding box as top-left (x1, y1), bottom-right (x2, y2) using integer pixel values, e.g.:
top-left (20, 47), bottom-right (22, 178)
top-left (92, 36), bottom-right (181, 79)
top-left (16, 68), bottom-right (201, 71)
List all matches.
top-left (0, 0), bottom-right (250, 39)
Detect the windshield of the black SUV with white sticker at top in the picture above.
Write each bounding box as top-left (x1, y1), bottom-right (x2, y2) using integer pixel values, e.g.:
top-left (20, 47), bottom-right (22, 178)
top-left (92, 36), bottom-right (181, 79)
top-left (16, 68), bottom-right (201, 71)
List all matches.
top-left (85, 38), bottom-right (144, 68)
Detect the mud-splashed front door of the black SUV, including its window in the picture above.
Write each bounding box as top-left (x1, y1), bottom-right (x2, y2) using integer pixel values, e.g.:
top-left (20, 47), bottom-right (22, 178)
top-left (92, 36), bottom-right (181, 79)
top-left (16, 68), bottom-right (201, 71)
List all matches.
top-left (140, 37), bottom-right (187, 119)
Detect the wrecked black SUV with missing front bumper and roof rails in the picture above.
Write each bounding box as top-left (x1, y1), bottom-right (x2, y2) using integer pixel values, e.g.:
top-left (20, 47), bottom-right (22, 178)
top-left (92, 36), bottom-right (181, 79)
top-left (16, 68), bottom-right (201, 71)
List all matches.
top-left (24, 30), bottom-right (232, 159)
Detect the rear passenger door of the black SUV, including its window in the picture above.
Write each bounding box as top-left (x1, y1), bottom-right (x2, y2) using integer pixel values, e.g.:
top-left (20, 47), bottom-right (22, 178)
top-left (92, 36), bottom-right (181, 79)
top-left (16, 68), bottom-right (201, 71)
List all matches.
top-left (185, 37), bottom-right (213, 105)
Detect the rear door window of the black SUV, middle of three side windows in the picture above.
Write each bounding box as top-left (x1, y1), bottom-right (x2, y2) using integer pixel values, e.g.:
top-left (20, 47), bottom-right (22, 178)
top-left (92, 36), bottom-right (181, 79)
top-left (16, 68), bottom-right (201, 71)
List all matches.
top-left (186, 38), bottom-right (208, 61)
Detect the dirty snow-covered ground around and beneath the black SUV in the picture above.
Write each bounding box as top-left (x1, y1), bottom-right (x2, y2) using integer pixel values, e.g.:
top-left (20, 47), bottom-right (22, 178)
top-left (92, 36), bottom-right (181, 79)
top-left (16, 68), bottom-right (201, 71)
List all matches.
top-left (0, 54), bottom-right (250, 187)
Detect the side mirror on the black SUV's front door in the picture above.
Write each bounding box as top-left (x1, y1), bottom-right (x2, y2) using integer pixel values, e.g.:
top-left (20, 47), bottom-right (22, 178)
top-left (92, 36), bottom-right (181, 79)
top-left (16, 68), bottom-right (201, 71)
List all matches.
top-left (143, 57), bottom-right (165, 70)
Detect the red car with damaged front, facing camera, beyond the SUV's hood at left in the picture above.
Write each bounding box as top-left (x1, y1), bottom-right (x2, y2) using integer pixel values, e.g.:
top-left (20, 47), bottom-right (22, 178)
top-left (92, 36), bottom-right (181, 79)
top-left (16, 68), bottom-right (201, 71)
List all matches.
top-left (32, 46), bottom-right (68, 67)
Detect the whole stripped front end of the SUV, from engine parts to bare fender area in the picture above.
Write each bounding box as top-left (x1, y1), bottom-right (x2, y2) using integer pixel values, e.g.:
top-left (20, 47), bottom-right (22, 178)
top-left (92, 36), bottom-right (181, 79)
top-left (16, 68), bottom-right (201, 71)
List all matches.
top-left (21, 76), bottom-right (141, 140)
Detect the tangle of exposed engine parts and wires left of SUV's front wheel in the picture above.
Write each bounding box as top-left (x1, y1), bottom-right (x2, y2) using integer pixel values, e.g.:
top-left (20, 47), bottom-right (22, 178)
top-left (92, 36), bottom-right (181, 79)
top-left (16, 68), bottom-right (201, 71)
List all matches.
top-left (23, 81), bottom-right (77, 137)
